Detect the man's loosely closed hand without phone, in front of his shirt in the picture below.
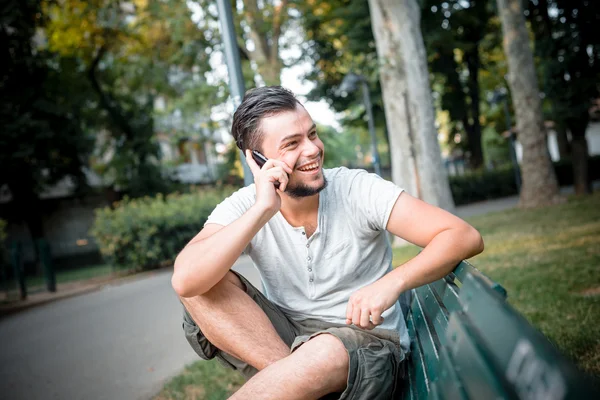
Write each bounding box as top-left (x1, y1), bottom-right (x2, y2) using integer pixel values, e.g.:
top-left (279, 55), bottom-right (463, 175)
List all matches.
top-left (346, 277), bottom-right (400, 329)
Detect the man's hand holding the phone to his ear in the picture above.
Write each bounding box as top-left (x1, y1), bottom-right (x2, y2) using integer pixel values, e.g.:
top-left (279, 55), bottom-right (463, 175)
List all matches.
top-left (246, 150), bottom-right (292, 215)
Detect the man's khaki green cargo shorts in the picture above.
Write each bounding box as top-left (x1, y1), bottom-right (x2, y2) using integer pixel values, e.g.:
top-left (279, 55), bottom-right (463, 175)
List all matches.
top-left (183, 271), bottom-right (404, 400)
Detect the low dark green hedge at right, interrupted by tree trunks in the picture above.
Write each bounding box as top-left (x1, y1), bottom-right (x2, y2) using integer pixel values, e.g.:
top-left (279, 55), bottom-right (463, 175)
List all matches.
top-left (449, 156), bottom-right (600, 206)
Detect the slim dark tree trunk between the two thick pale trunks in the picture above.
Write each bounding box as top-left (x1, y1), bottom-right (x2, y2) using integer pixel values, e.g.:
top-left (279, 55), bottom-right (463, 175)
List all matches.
top-left (465, 45), bottom-right (483, 168)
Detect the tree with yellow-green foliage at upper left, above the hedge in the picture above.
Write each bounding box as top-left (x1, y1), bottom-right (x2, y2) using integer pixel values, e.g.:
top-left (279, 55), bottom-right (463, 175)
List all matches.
top-left (44, 0), bottom-right (223, 196)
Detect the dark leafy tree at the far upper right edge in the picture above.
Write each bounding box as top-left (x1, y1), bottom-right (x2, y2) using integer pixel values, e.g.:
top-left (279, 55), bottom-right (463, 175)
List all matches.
top-left (527, 0), bottom-right (600, 194)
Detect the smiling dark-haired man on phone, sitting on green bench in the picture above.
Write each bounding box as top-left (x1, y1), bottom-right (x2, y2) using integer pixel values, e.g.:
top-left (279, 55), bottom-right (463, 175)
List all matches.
top-left (172, 87), bottom-right (483, 399)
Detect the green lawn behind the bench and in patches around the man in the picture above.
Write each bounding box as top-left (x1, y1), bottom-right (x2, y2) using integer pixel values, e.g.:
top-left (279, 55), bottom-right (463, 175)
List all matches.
top-left (155, 193), bottom-right (600, 400)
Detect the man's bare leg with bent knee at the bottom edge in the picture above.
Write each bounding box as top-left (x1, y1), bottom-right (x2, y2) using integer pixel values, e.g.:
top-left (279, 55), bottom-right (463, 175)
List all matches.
top-left (230, 334), bottom-right (350, 400)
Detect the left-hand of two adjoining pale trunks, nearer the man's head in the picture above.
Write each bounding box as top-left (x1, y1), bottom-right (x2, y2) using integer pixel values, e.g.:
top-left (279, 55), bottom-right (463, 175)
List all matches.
top-left (369, 0), bottom-right (422, 198)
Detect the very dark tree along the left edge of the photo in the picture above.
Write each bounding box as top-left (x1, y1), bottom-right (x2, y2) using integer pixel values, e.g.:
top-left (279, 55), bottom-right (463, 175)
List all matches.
top-left (0, 0), bottom-right (92, 247)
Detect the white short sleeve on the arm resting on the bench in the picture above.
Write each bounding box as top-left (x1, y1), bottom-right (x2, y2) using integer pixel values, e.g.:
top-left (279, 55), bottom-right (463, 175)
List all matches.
top-left (348, 170), bottom-right (404, 231)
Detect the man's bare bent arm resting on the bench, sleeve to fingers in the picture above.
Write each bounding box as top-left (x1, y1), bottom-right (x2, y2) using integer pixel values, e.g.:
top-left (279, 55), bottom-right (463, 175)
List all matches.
top-left (346, 192), bottom-right (483, 329)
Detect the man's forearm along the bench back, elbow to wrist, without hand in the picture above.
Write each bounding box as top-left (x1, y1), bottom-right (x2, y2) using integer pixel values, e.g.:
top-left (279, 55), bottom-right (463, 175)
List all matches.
top-left (383, 228), bottom-right (483, 294)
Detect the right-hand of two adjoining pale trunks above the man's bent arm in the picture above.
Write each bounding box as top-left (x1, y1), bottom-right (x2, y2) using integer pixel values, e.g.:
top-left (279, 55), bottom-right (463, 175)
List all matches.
top-left (394, 0), bottom-right (454, 212)
